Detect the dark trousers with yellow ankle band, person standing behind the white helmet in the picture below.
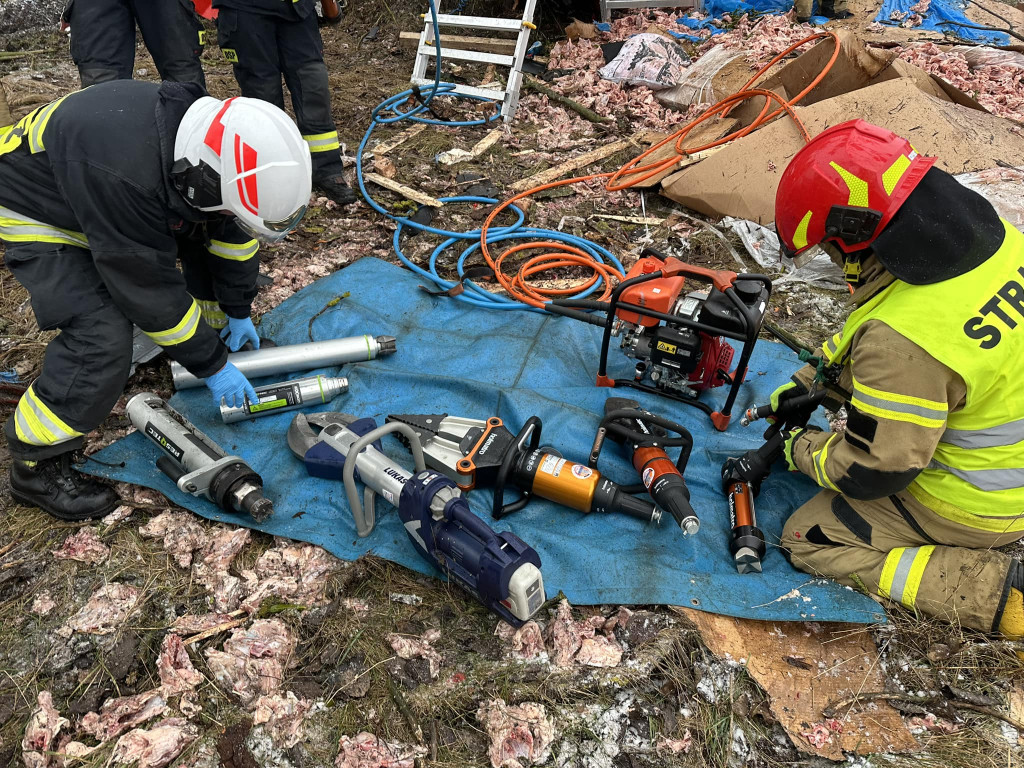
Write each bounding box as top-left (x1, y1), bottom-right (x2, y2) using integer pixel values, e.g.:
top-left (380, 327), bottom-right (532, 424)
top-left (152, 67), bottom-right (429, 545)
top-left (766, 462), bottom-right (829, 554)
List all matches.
top-left (217, 8), bottom-right (343, 179)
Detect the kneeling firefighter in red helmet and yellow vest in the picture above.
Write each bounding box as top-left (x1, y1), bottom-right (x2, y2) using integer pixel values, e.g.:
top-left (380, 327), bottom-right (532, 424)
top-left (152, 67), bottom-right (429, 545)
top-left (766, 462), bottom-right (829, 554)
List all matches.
top-left (772, 120), bottom-right (1024, 638)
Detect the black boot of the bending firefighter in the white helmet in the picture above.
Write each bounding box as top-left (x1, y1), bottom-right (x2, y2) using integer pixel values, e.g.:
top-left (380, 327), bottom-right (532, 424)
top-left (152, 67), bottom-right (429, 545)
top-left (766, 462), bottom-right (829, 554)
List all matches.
top-left (10, 453), bottom-right (121, 520)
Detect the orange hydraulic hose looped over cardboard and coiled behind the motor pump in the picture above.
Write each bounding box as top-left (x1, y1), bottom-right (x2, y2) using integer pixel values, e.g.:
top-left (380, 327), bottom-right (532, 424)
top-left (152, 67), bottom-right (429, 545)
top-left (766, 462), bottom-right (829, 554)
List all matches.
top-left (480, 30), bottom-right (840, 307)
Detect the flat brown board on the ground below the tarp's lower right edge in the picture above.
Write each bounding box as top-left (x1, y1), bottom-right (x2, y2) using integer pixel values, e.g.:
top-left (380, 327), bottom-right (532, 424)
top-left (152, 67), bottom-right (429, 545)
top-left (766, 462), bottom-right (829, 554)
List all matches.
top-left (674, 608), bottom-right (918, 760)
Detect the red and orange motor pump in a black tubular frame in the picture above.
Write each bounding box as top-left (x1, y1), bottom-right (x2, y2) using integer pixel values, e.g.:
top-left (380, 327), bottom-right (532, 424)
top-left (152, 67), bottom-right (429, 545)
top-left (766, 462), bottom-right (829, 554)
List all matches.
top-left (545, 248), bottom-right (771, 431)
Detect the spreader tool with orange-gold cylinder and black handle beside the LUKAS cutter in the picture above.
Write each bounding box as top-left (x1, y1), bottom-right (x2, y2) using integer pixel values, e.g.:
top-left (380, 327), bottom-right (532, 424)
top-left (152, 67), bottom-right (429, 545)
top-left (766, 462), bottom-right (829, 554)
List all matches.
top-left (387, 414), bottom-right (662, 524)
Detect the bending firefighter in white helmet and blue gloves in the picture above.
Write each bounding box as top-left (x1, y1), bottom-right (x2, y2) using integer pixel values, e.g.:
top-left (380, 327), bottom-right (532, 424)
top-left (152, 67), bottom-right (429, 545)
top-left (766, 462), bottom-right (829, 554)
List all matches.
top-left (0, 80), bottom-right (311, 520)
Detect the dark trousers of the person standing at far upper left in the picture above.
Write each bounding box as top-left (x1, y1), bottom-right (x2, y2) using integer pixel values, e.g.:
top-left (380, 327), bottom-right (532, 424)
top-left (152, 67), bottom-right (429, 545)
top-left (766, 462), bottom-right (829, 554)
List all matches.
top-left (63, 0), bottom-right (206, 88)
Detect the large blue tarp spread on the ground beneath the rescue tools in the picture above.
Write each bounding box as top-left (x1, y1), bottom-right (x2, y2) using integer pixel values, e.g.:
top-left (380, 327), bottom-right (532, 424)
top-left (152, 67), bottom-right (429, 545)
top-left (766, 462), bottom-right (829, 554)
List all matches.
top-left (89, 258), bottom-right (884, 623)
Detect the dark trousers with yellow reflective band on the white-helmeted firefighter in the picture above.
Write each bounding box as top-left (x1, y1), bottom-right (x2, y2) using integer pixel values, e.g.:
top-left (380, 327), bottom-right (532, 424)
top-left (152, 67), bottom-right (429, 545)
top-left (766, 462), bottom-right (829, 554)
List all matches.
top-left (4, 243), bottom-right (219, 461)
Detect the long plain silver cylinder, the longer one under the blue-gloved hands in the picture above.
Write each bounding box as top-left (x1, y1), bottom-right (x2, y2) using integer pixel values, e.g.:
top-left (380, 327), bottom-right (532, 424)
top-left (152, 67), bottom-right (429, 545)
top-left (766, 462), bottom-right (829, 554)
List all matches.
top-left (171, 336), bottom-right (396, 389)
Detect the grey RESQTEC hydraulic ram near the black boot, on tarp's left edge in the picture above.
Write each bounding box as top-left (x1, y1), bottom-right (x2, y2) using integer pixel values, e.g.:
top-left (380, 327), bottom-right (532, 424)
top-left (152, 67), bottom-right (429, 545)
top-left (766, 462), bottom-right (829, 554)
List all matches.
top-left (125, 392), bottom-right (273, 522)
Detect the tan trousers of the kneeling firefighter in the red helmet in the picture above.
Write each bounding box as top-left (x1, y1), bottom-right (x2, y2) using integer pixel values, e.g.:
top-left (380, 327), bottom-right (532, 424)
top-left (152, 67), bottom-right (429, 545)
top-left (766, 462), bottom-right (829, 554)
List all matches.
top-left (781, 490), bottom-right (1024, 632)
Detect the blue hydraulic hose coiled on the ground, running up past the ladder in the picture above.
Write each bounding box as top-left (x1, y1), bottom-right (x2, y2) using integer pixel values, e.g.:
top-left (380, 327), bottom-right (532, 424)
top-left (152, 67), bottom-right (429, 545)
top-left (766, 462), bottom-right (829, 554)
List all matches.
top-left (355, 0), bottom-right (625, 311)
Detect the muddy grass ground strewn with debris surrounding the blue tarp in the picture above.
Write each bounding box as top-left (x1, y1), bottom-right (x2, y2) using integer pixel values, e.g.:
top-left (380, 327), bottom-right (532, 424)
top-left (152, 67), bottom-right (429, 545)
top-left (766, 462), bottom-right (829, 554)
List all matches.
top-left (0, 0), bottom-right (1024, 768)
